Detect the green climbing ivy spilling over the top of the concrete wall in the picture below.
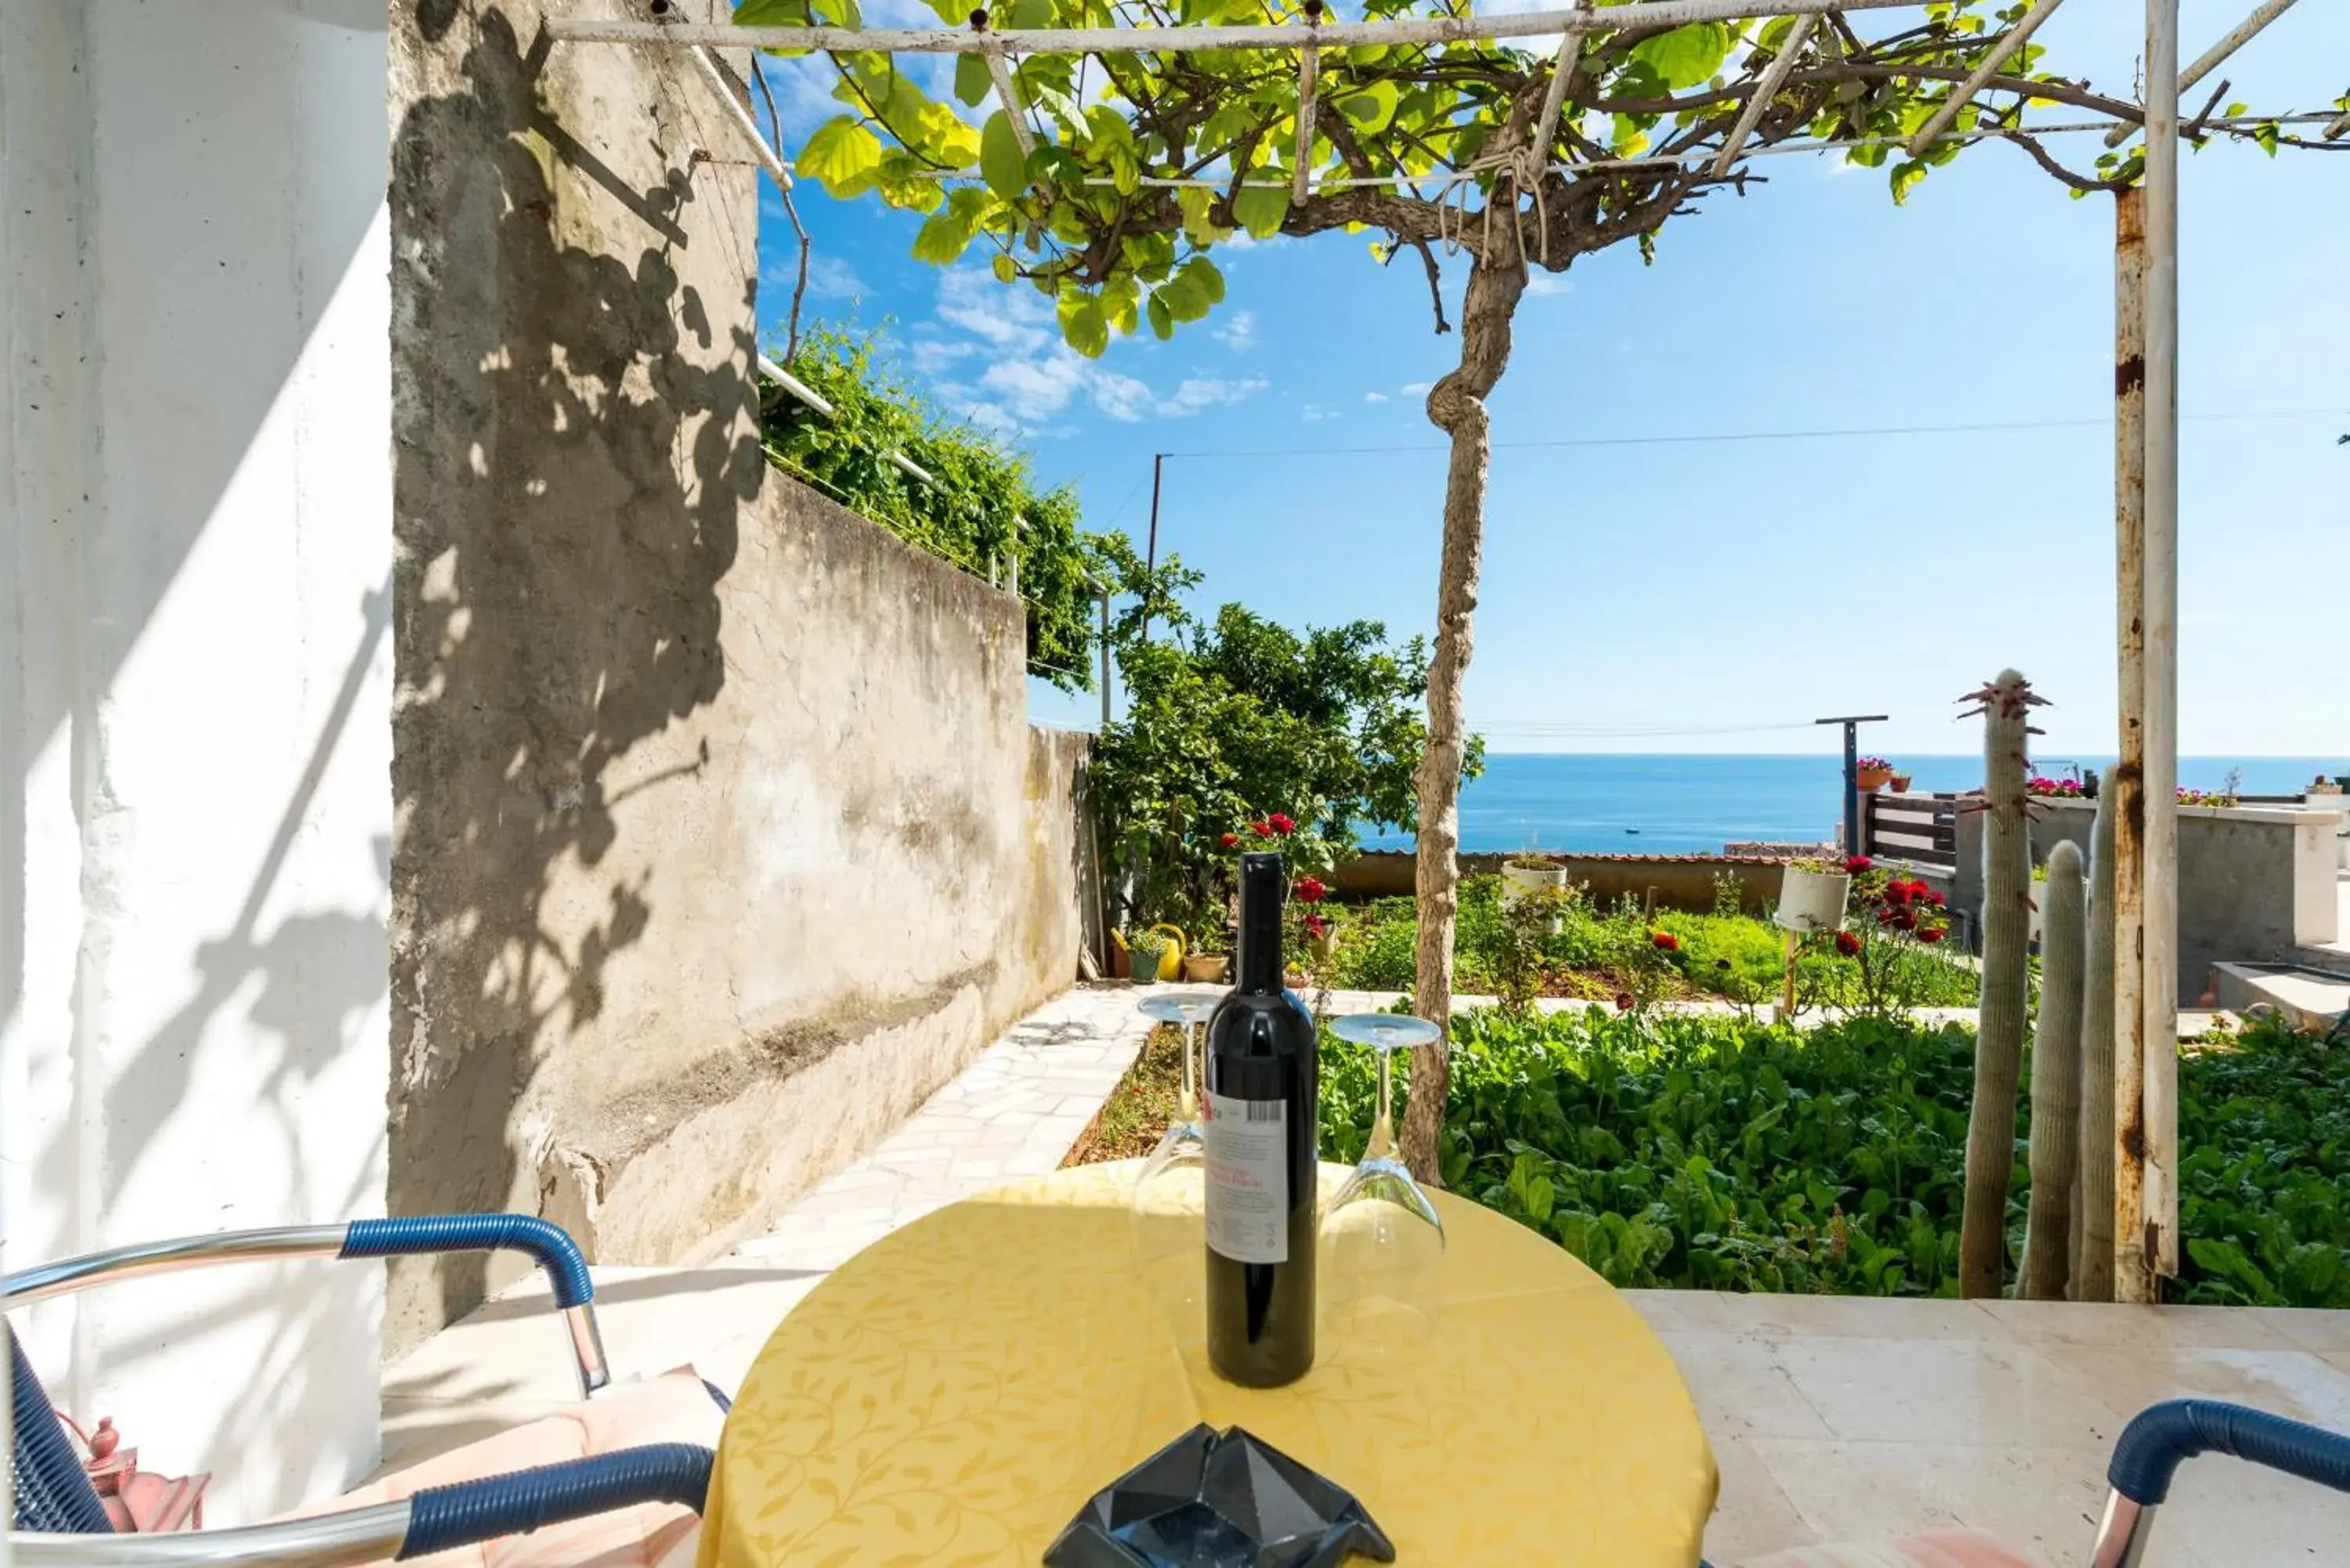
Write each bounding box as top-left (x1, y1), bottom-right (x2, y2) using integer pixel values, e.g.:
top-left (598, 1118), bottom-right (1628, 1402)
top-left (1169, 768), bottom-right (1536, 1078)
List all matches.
top-left (759, 329), bottom-right (1107, 691)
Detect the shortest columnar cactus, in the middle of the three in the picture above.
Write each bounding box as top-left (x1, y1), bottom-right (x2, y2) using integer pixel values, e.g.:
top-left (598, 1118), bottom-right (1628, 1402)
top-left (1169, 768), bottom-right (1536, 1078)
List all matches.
top-left (2016, 840), bottom-right (2089, 1302)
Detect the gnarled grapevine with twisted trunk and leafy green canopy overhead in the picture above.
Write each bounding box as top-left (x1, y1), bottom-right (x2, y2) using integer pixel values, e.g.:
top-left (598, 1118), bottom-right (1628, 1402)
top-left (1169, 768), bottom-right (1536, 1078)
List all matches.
top-left (736, 0), bottom-right (2265, 1176)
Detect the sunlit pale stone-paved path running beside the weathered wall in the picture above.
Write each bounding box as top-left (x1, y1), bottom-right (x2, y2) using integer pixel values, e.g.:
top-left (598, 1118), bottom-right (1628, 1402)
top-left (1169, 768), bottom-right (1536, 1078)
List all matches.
top-left (726, 985), bottom-right (1149, 1270)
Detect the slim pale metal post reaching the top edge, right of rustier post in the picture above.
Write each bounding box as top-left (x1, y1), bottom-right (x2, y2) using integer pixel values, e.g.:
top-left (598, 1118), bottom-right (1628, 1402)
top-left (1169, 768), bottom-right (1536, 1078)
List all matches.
top-left (2141, 0), bottom-right (2178, 1277)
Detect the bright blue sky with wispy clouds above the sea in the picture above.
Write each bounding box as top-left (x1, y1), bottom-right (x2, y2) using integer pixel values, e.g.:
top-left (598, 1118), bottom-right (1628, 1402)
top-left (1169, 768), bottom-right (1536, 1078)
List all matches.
top-left (759, 0), bottom-right (2350, 754)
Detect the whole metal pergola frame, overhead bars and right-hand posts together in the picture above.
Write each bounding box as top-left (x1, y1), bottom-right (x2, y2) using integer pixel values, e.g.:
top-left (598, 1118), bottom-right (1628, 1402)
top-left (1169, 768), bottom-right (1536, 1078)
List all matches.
top-left (545, 0), bottom-right (2350, 1302)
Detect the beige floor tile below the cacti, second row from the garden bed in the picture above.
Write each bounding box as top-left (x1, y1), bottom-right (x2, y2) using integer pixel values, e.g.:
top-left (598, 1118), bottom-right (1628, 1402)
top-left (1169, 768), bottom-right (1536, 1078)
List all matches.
top-left (1777, 1338), bottom-right (2122, 1451)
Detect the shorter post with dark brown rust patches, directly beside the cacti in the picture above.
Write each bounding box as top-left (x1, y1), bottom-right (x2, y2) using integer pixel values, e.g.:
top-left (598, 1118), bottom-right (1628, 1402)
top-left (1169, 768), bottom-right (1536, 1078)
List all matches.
top-left (2099, 186), bottom-right (2153, 1302)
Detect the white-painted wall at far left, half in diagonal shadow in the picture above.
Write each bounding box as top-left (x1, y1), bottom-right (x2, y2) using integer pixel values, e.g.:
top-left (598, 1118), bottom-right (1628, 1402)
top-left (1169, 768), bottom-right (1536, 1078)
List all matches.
top-left (0, 0), bottom-right (392, 1523)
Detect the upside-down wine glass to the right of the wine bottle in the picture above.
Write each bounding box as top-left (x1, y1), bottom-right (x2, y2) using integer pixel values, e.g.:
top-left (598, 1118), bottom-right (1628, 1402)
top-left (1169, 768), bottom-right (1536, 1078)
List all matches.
top-left (1321, 1013), bottom-right (1445, 1354)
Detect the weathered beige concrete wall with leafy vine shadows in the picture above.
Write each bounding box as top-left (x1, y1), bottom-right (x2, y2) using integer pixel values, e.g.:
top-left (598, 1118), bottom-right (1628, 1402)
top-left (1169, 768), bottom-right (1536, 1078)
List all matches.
top-left (390, 0), bottom-right (1076, 1347)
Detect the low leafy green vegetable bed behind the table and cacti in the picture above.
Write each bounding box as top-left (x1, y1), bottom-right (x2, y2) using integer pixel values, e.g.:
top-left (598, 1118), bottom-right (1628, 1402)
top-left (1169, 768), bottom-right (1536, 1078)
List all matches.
top-left (1323, 1013), bottom-right (2350, 1307)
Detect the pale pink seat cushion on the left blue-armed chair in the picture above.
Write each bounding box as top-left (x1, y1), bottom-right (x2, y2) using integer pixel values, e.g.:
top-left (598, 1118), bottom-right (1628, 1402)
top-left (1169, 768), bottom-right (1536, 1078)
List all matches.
top-left (289, 1368), bottom-right (724, 1568)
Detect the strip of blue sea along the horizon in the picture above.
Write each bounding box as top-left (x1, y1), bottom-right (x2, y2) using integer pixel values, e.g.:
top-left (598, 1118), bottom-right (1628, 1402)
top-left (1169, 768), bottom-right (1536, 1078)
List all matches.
top-left (1363, 752), bottom-right (2350, 856)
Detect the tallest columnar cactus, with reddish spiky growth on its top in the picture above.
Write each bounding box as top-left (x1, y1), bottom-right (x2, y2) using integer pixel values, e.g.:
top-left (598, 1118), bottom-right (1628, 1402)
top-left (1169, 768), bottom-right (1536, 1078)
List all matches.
top-left (1958, 670), bottom-right (2042, 1298)
